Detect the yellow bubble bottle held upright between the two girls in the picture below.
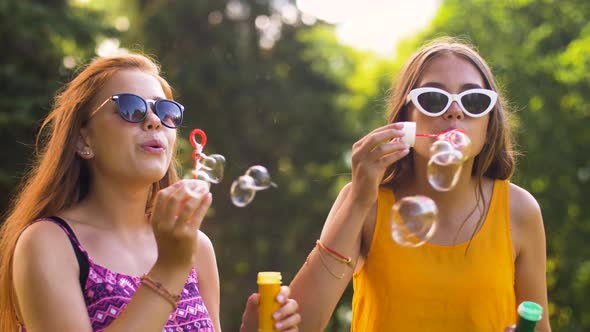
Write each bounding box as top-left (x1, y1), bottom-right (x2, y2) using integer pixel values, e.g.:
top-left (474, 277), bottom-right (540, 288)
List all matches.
top-left (258, 272), bottom-right (281, 332)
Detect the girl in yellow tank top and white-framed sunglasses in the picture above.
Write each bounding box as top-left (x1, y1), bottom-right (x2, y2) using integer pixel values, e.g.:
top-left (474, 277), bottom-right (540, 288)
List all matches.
top-left (291, 39), bottom-right (550, 332)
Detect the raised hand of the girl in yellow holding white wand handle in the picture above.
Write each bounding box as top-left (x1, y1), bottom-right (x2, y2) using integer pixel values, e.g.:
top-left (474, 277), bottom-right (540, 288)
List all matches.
top-left (351, 123), bottom-right (410, 204)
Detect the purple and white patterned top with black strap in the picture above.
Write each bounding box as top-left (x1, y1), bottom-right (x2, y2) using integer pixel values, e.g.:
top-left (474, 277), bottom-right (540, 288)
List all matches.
top-left (21, 218), bottom-right (215, 332)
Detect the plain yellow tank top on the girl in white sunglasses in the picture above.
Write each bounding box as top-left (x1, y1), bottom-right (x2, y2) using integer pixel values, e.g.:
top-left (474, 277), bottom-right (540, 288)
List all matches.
top-left (352, 180), bottom-right (516, 332)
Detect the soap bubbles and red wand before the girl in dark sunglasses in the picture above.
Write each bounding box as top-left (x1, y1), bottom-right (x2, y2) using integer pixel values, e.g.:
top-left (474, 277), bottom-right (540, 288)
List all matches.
top-left (185, 129), bottom-right (276, 207)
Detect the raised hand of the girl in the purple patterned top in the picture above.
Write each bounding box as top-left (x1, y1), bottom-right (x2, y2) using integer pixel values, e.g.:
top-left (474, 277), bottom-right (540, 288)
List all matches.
top-left (151, 180), bottom-right (212, 269)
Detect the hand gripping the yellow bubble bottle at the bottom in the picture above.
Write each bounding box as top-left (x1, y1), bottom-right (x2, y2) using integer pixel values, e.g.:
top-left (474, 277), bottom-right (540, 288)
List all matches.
top-left (240, 286), bottom-right (301, 332)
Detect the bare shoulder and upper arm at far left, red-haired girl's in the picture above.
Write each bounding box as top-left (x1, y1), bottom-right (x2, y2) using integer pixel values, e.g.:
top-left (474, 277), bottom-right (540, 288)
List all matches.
top-left (13, 217), bottom-right (90, 331)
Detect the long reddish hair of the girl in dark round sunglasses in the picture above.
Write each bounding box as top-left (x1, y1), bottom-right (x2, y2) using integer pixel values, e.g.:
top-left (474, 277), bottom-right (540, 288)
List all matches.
top-left (0, 54), bottom-right (178, 331)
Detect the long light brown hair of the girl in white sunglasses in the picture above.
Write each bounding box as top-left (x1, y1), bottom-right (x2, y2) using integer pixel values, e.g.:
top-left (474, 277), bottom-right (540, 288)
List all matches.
top-left (382, 37), bottom-right (518, 248)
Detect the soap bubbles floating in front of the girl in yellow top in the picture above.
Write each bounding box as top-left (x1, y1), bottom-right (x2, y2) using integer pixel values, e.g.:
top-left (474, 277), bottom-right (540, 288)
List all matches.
top-left (391, 127), bottom-right (471, 247)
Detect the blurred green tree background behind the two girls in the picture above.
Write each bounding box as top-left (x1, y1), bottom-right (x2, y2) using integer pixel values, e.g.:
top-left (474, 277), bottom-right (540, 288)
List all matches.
top-left (0, 0), bottom-right (590, 331)
